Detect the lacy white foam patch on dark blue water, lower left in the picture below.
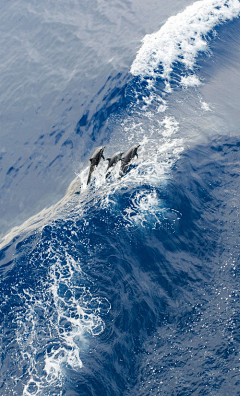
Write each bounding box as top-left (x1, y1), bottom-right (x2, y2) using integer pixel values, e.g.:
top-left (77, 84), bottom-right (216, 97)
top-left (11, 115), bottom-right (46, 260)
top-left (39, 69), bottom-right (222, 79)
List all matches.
top-left (13, 246), bottom-right (110, 396)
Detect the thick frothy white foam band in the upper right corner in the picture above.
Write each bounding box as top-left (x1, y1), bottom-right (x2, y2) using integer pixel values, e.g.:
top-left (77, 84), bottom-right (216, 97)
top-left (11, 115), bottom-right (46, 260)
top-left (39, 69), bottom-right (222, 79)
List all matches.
top-left (131, 0), bottom-right (240, 86)
